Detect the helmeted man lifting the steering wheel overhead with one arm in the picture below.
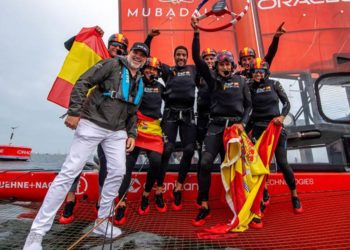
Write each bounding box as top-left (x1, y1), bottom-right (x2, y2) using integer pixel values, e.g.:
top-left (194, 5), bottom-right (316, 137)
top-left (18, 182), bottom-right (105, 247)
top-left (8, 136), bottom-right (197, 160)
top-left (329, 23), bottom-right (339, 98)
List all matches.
top-left (192, 18), bottom-right (251, 226)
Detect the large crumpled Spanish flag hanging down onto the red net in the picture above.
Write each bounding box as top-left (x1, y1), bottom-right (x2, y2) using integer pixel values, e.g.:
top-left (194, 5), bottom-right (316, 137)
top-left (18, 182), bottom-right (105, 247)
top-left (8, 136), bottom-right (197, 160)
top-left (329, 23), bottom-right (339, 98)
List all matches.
top-left (197, 122), bottom-right (281, 238)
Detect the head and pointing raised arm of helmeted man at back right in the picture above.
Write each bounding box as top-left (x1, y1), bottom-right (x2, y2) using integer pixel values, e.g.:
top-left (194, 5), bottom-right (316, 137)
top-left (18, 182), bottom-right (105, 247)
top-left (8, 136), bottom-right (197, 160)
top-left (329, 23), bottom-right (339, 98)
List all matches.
top-left (236, 22), bottom-right (286, 78)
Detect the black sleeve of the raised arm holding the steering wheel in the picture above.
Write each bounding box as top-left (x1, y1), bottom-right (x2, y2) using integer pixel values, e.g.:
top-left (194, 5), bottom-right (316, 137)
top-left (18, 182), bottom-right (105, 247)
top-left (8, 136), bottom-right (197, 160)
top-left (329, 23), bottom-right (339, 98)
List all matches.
top-left (192, 32), bottom-right (214, 90)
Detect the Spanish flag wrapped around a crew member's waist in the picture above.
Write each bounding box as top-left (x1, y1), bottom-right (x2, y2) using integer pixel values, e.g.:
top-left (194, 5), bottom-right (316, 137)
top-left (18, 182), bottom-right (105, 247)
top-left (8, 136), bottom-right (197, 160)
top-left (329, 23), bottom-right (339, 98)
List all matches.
top-left (135, 111), bottom-right (164, 154)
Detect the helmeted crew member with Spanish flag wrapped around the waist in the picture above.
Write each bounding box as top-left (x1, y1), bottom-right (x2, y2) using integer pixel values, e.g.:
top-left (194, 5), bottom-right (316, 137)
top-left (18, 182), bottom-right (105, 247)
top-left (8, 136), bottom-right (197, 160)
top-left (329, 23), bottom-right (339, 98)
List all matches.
top-left (114, 57), bottom-right (167, 225)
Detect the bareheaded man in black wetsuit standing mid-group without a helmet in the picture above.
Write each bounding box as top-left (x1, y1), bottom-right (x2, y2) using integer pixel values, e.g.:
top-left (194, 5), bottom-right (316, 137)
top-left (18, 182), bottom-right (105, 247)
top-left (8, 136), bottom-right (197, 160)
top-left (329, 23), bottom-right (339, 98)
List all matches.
top-left (145, 31), bottom-right (197, 210)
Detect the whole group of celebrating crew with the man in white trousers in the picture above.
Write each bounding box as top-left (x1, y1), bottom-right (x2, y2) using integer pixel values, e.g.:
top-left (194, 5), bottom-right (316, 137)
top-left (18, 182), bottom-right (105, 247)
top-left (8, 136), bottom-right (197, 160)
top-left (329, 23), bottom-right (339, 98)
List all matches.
top-left (24, 18), bottom-right (303, 249)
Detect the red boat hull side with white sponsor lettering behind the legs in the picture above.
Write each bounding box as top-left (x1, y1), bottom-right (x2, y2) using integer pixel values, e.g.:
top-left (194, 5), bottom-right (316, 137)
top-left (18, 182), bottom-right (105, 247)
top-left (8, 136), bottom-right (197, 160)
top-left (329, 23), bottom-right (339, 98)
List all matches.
top-left (0, 170), bottom-right (350, 203)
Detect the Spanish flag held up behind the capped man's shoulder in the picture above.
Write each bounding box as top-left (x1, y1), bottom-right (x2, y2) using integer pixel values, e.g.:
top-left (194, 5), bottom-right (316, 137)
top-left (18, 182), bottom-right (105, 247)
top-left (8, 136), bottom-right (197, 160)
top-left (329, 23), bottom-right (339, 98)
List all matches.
top-left (47, 27), bottom-right (110, 108)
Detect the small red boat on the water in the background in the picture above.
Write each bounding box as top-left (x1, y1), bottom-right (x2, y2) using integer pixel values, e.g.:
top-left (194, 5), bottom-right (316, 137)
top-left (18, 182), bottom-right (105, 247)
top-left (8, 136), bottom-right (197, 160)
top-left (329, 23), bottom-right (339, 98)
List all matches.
top-left (0, 127), bottom-right (32, 161)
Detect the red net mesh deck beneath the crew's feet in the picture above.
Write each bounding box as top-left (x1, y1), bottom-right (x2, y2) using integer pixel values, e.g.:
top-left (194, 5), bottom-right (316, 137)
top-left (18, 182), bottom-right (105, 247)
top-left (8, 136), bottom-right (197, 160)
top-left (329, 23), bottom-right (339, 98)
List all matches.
top-left (0, 191), bottom-right (350, 249)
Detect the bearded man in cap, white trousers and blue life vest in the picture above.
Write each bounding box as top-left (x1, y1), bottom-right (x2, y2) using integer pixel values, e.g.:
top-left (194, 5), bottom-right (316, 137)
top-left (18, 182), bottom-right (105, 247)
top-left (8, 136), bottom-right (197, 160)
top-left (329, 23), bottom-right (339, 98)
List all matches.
top-left (24, 43), bottom-right (149, 249)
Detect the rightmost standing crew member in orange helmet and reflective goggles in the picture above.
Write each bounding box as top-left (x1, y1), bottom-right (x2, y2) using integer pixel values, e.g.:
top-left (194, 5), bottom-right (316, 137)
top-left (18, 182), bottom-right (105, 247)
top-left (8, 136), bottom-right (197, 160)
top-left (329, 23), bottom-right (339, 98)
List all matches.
top-left (249, 58), bottom-right (303, 227)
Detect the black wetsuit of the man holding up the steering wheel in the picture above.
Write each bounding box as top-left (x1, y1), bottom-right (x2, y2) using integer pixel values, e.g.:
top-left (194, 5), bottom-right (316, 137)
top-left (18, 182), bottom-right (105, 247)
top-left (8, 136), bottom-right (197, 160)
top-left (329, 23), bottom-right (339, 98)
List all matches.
top-left (192, 33), bottom-right (251, 201)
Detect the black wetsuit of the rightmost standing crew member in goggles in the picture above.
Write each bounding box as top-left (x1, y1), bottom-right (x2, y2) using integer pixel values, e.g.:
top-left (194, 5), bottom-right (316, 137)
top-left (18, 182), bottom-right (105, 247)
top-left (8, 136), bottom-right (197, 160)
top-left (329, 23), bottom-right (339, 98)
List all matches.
top-left (249, 79), bottom-right (296, 190)
